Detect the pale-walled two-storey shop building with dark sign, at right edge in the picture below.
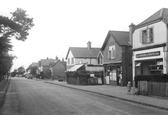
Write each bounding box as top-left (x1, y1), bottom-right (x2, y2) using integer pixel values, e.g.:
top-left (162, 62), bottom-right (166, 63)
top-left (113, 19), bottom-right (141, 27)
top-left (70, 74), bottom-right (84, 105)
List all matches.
top-left (132, 8), bottom-right (168, 80)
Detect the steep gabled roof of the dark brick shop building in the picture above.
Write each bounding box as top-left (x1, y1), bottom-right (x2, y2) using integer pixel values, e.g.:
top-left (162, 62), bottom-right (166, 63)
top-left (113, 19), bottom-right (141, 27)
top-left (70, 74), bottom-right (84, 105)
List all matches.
top-left (101, 31), bottom-right (130, 50)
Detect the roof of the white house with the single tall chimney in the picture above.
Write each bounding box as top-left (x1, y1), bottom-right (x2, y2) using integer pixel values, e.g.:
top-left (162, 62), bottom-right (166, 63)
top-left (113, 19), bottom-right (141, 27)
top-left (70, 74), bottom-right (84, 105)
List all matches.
top-left (66, 47), bottom-right (100, 59)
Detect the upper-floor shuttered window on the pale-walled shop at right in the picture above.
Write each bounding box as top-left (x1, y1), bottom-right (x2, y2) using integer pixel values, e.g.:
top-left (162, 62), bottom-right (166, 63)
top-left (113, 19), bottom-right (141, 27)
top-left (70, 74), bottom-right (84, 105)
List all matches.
top-left (140, 28), bottom-right (153, 44)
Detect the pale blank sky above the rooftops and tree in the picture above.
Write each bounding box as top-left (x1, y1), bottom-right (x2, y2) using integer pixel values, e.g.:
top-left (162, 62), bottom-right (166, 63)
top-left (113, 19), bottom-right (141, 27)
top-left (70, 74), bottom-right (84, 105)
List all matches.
top-left (0, 0), bottom-right (168, 70)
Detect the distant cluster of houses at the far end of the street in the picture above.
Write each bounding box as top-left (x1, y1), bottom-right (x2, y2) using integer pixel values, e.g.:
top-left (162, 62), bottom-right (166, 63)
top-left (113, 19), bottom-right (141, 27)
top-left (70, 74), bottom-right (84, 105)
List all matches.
top-left (27, 56), bottom-right (66, 81)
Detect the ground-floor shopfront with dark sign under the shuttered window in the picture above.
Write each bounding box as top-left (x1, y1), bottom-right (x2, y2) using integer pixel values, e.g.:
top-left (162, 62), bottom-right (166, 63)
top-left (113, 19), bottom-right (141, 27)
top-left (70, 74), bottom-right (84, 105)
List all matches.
top-left (133, 47), bottom-right (167, 76)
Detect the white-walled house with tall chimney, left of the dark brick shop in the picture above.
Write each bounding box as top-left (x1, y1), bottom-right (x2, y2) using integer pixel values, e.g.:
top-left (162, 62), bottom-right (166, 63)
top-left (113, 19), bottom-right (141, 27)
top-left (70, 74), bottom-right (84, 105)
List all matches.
top-left (66, 41), bottom-right (100, 71)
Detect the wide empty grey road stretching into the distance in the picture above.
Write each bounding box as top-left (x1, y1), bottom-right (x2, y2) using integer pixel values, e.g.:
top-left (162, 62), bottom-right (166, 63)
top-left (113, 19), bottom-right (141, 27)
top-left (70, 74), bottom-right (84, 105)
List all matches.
top-left (0, 78), bottom-right (168, 115)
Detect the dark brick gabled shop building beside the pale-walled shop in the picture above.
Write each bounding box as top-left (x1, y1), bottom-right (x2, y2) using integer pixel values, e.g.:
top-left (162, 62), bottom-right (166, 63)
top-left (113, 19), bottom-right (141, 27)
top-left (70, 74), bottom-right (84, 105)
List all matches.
top-left (97, 31), bottom-right (132, 86)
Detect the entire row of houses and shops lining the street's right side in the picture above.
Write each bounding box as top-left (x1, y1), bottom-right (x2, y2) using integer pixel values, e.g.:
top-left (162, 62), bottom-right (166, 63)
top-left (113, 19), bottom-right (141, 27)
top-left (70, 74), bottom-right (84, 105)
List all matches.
top-left (27, 8), bottom-right (168, 86)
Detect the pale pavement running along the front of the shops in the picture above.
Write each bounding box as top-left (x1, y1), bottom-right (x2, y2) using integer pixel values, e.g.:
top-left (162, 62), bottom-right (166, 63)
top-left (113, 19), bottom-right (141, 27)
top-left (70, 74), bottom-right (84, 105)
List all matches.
top-left (44, 80), bottom-right (168, 110)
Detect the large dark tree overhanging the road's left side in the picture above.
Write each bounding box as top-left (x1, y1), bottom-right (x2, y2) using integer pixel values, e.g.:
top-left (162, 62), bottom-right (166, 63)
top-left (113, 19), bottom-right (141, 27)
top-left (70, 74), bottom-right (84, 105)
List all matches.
top-left (0, 8), bottom-right (34, 78)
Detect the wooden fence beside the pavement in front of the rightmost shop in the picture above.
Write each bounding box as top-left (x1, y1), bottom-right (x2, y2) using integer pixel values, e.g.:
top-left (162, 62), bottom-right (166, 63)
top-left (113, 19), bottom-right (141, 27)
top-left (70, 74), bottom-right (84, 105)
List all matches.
top-left (138, 81), bottom-right (168, 97)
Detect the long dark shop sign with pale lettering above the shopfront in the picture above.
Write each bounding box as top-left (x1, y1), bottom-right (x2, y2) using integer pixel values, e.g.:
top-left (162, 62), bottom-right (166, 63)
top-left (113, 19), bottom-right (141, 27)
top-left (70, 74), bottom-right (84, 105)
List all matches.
top-left (136, 51), bottom-right (160, 58)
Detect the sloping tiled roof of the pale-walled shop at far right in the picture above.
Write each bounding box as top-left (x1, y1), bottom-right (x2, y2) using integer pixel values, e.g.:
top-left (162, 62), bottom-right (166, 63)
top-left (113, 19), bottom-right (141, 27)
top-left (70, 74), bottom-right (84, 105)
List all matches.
top-left (135, 8), bottom-right (168, 28)
